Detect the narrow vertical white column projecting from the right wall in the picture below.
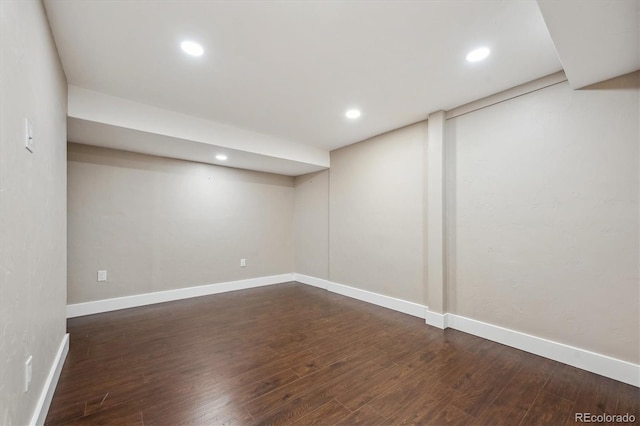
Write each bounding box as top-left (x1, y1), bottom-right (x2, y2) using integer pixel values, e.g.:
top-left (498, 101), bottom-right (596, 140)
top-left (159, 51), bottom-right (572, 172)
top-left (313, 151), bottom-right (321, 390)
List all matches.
top-left (425, 111), bottom-right (446, 320)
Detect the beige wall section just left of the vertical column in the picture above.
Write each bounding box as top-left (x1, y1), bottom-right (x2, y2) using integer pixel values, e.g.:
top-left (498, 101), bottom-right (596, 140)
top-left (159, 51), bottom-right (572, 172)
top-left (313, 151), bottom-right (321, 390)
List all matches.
top-left (329, 122), bottom-right (427, 304)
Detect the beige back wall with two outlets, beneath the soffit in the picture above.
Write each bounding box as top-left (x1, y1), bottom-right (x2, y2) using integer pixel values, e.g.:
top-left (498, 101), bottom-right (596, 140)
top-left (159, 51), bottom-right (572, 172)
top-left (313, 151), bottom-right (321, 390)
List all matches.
top-left (68, 144), bottom-right (294, 304)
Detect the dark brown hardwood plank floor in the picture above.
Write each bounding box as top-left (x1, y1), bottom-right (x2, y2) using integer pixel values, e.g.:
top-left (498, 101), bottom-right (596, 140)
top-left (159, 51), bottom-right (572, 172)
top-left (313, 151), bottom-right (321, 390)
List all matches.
top-left (46, 283), bottom-right (640, 425)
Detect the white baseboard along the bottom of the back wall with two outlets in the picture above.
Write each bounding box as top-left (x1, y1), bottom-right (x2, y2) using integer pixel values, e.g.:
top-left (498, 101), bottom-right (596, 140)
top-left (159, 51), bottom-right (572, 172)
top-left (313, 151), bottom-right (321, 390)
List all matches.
top-left (67, 273), bottom-right (293, 318)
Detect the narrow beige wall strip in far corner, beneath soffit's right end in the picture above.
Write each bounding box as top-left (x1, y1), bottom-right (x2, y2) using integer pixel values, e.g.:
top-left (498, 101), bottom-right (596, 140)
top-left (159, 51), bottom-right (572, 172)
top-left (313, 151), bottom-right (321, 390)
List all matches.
top-left (294, 170), bottom-right (329, 280)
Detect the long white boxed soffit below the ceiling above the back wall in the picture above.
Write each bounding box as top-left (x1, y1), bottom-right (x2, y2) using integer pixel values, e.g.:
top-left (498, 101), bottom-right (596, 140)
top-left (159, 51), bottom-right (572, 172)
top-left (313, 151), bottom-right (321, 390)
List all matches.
top-left (68, 86), bottom-right (329, 176)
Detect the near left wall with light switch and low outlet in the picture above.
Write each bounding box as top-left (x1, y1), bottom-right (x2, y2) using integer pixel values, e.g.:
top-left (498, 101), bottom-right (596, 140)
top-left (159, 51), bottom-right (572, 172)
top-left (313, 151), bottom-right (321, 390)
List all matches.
top-left (0, 0), bottom-right (67, 425)
